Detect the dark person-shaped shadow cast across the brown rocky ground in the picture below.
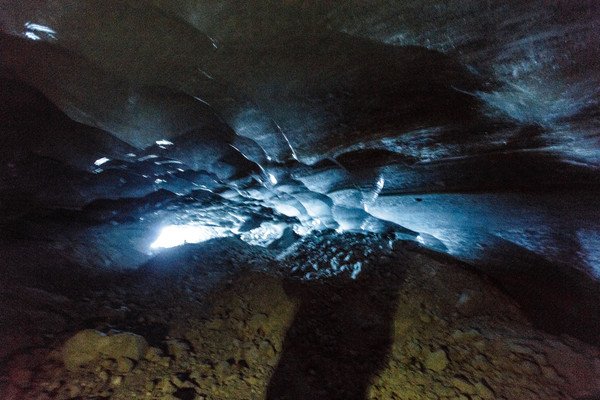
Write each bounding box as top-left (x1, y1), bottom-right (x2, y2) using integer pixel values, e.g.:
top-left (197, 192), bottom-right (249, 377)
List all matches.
top-left (267, 261), bottom-right (405, 400)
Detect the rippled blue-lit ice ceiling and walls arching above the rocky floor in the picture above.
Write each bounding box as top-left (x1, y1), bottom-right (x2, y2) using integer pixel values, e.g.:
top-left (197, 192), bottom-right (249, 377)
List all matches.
top-left (0, 0), bottom-right (600, 277)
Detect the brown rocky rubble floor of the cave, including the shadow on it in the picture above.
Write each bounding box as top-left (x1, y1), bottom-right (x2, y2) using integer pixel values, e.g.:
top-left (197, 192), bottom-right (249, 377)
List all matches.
top-left (0, 234), bottom-right (600, 400)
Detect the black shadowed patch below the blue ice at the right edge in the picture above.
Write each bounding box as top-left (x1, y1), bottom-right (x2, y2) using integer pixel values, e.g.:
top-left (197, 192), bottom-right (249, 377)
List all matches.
top-left (474, 234), bottom-right (600, 346)
